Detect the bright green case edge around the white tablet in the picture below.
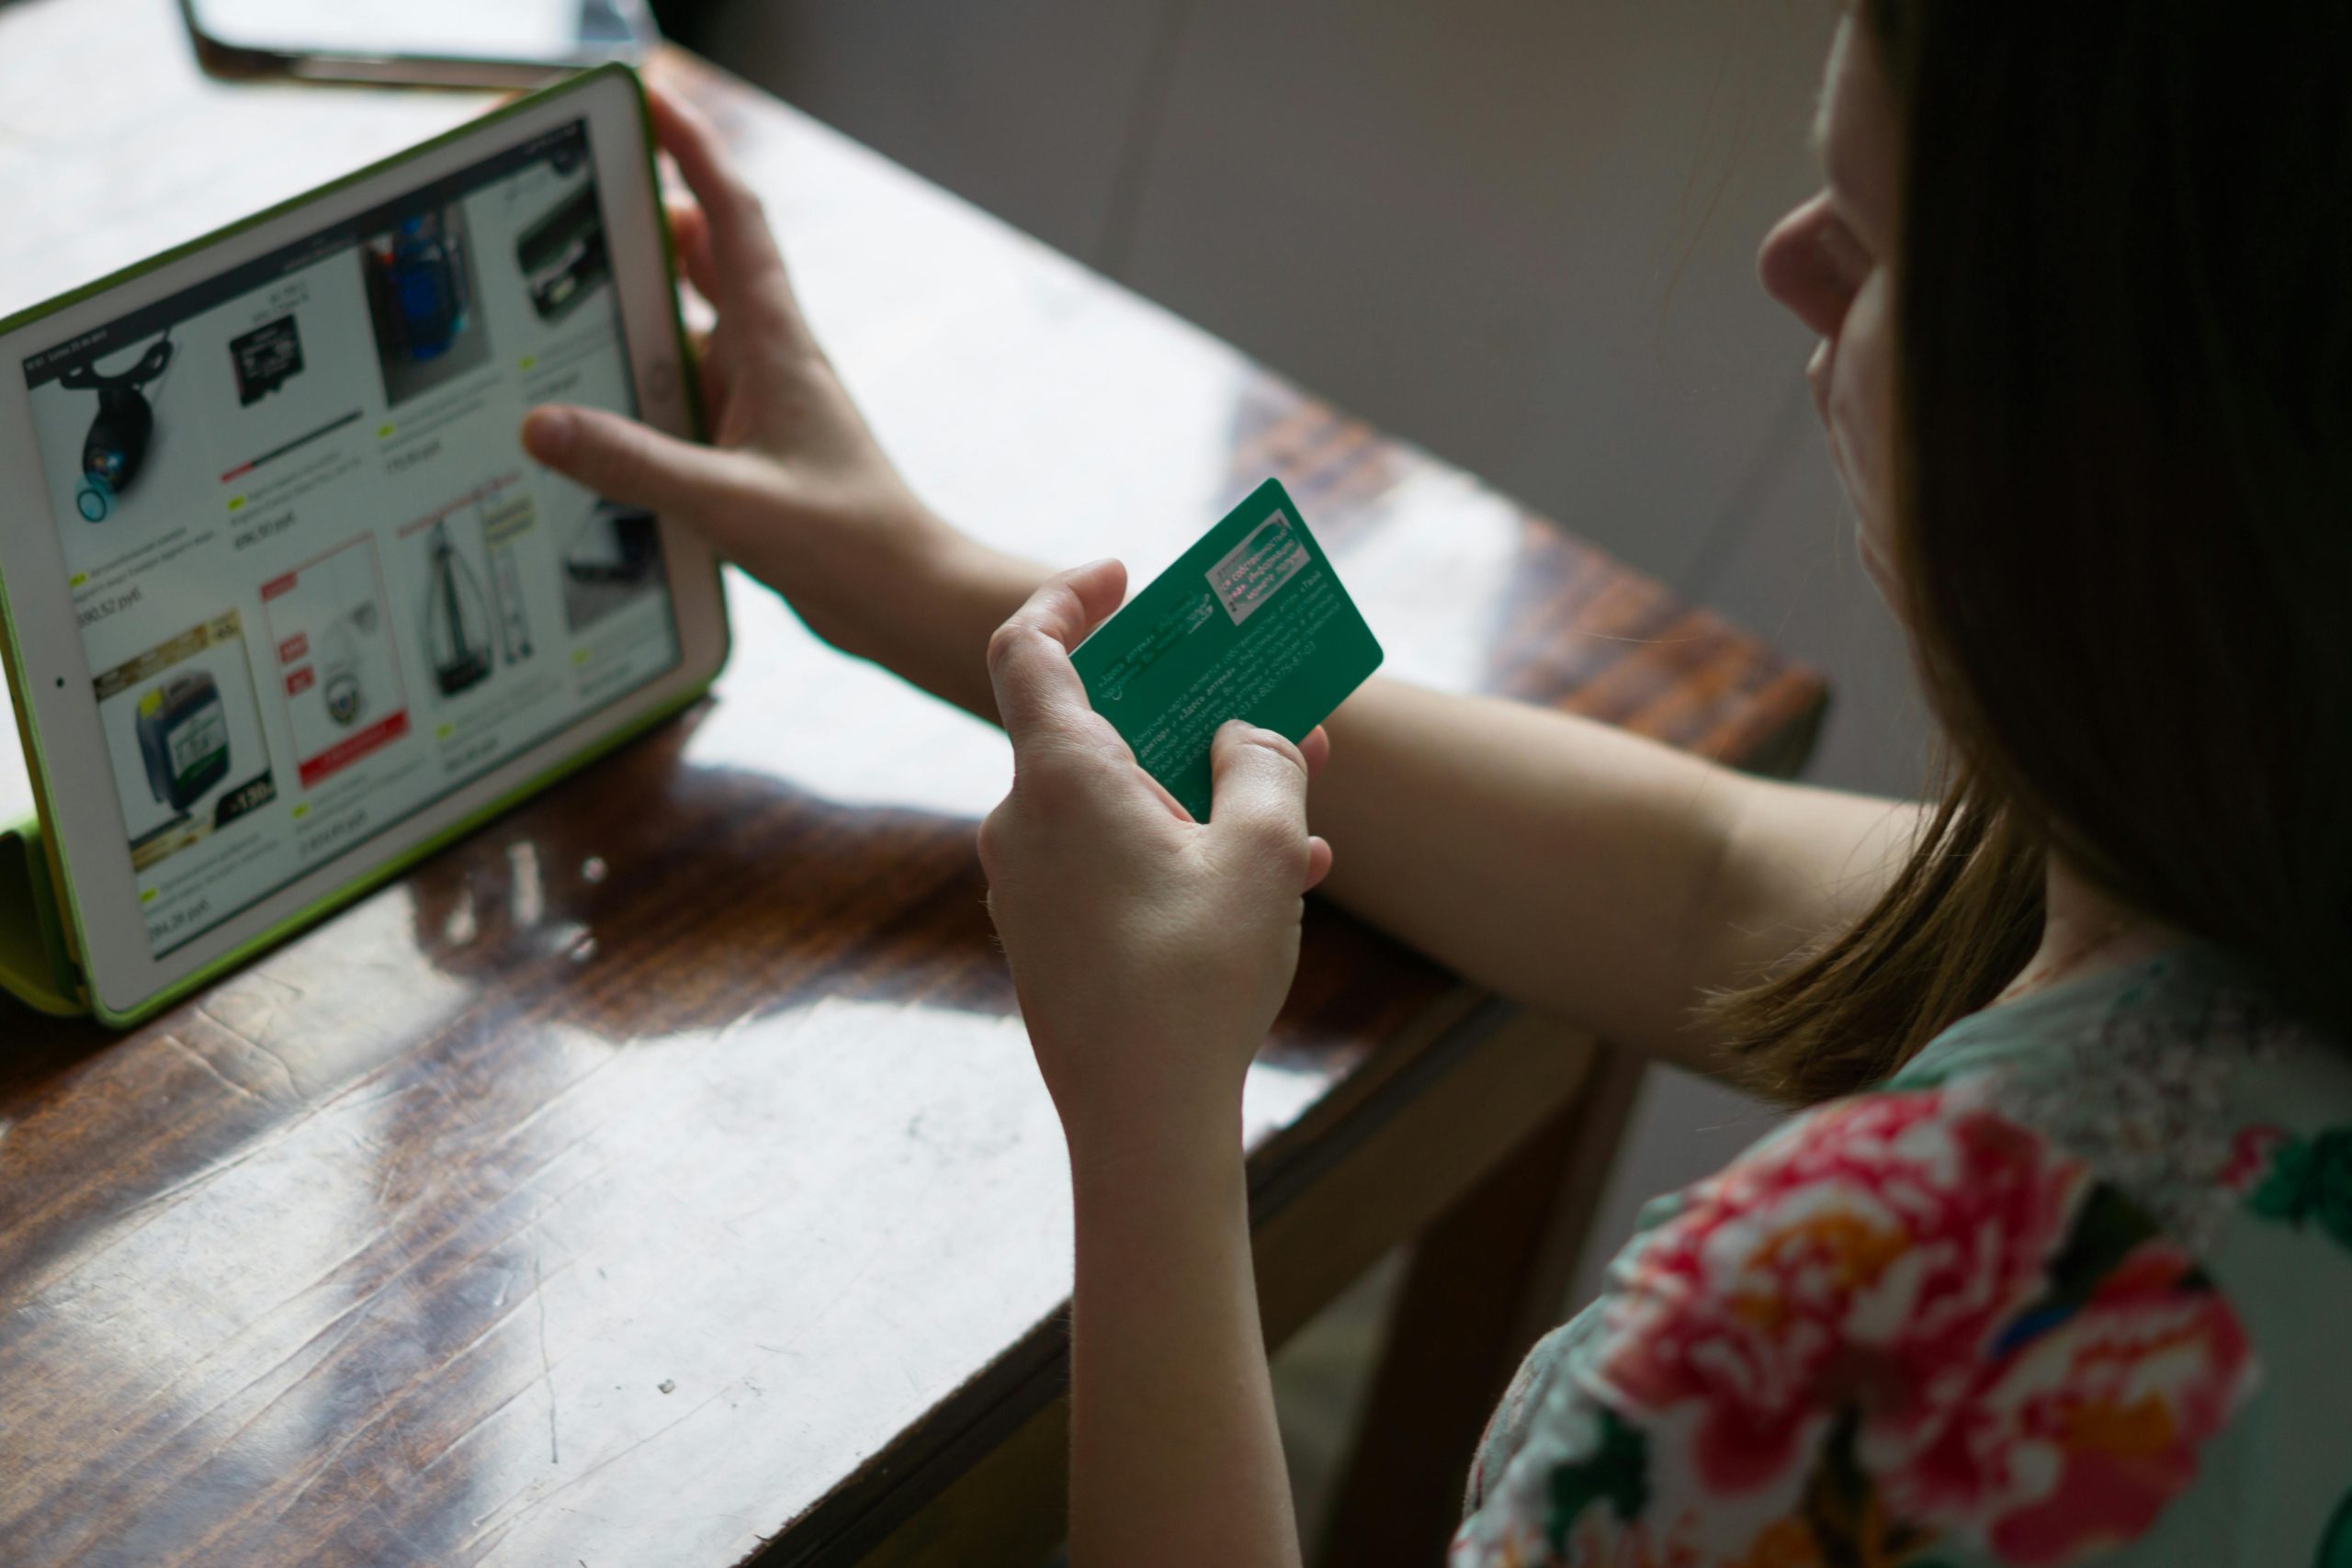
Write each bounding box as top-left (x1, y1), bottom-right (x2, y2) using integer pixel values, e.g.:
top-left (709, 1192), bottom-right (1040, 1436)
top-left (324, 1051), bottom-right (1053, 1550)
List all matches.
top-left (0, 66), bottom-right (727, 1025)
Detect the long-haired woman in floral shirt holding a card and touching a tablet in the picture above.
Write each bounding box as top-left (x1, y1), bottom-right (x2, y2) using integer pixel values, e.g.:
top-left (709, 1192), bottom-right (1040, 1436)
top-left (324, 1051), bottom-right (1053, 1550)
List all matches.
top-left (526, 0), bottom-right (2352, 1568)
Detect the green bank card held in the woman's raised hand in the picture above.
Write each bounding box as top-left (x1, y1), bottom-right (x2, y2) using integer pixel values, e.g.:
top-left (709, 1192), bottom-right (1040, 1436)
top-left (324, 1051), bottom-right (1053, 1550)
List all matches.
top-left (1070, 479), bottom-right (1381, 823)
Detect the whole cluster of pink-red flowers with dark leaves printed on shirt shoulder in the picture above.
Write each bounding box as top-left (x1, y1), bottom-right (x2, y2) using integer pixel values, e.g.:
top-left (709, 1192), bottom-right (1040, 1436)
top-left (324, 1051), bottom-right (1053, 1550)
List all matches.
top-left (1595, 1090), bottom-right (2256, 1565)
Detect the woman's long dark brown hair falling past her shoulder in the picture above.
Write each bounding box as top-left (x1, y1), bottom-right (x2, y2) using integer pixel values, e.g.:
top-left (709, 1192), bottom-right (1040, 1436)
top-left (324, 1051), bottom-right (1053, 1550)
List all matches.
top-left (1714, 0), bottom-right (2352, 1100)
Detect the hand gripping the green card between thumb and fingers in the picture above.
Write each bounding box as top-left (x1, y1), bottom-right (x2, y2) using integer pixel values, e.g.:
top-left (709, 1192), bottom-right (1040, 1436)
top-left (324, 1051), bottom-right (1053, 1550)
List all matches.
top-left (981, 562), bottom-right (1331, 1161)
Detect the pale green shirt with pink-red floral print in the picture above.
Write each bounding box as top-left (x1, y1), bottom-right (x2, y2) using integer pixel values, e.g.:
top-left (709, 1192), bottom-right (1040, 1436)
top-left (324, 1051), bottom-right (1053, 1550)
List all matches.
top-left (1452, 945), bottom-right (2352, 1568)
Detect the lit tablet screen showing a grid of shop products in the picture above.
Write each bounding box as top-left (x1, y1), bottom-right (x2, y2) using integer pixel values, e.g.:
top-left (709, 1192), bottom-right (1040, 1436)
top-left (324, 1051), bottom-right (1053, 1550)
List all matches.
top-left (24, 122), bottom-right (680, 957)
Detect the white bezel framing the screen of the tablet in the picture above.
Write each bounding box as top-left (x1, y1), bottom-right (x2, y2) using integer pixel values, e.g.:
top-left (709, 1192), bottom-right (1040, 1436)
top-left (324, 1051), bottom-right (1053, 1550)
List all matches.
top-left (0, 66), bottom-right (727, 1025)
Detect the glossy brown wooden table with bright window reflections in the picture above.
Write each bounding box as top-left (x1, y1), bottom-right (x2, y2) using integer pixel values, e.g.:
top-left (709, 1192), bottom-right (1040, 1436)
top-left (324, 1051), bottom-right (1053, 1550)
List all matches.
top-left (0, 0), bottom-right (1823, 1568)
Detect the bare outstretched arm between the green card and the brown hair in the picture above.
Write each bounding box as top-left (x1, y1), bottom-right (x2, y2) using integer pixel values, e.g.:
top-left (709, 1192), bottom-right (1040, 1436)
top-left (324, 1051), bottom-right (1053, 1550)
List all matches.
top-left (1310, 680), bottom-right (1917, 1069)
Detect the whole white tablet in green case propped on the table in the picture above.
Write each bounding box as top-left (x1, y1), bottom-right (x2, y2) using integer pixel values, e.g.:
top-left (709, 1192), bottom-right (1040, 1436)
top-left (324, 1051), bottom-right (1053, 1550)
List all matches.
top-left (0, 66), bottom-right (727, 1022)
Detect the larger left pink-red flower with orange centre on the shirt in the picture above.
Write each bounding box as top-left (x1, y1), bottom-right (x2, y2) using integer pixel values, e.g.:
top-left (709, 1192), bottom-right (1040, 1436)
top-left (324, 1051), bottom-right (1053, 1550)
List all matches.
top-left (1601, 1090), bottom-right (2088, 1495)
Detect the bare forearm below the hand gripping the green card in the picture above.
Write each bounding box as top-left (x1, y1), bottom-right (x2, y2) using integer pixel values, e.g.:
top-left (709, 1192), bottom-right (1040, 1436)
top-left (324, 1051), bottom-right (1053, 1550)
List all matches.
top-left (1070, 1123), bottom-right (1298, 1568)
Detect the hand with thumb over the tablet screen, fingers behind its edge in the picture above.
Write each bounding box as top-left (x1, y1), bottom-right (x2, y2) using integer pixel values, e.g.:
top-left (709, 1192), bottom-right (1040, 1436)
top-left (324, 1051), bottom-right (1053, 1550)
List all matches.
top-left (522, 89), bottom-right (950, 665)
